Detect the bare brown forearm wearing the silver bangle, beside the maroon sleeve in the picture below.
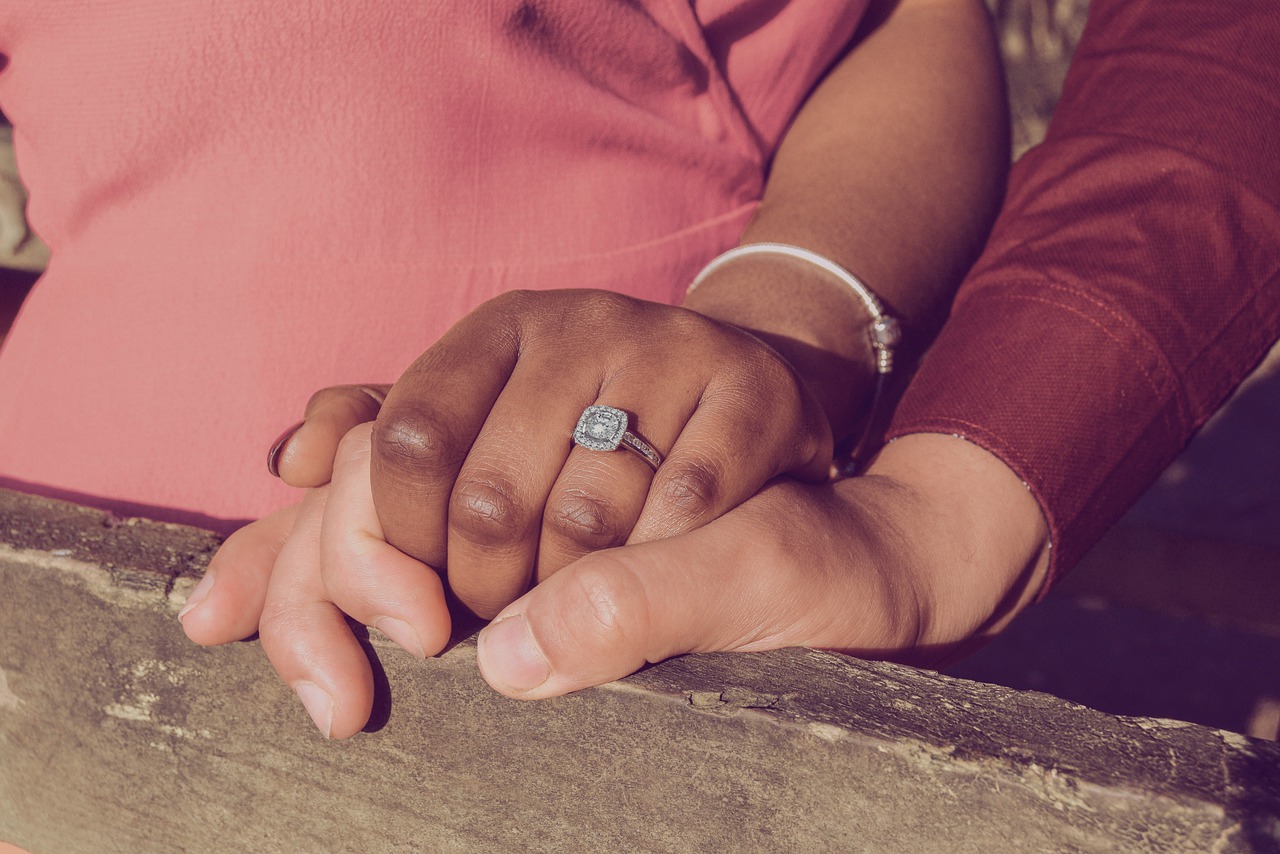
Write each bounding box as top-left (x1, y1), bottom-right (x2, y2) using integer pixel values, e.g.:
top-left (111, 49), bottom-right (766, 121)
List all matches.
top-left (686, 0), bottom-right (1009, 437)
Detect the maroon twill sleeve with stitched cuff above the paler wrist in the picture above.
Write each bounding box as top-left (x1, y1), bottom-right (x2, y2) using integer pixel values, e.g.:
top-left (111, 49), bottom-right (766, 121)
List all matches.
top-left (888, 0), bottom-right (1280, 580)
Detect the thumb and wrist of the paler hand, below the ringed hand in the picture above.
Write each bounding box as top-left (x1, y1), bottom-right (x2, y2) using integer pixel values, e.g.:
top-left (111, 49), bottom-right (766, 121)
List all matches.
top-left (477, 435), bottom-right (1048, 699)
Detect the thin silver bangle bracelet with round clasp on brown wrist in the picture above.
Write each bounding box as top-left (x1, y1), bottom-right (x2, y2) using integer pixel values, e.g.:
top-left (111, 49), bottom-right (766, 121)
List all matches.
top-left (687, 243), bottom-right (902, 474)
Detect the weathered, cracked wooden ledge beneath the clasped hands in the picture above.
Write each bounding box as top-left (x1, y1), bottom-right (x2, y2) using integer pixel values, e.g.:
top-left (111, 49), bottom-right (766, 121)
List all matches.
top-left (0, 493), bottom-right (1280, 854)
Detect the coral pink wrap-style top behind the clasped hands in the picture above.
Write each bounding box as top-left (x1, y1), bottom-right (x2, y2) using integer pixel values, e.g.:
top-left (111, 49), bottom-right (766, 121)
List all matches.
top-left (0, 0), bottom-right (865, 528)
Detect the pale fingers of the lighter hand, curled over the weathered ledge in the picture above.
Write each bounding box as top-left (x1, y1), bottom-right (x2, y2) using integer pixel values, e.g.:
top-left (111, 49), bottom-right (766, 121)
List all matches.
top-left (178, 425), bottom-right (452, 737)
